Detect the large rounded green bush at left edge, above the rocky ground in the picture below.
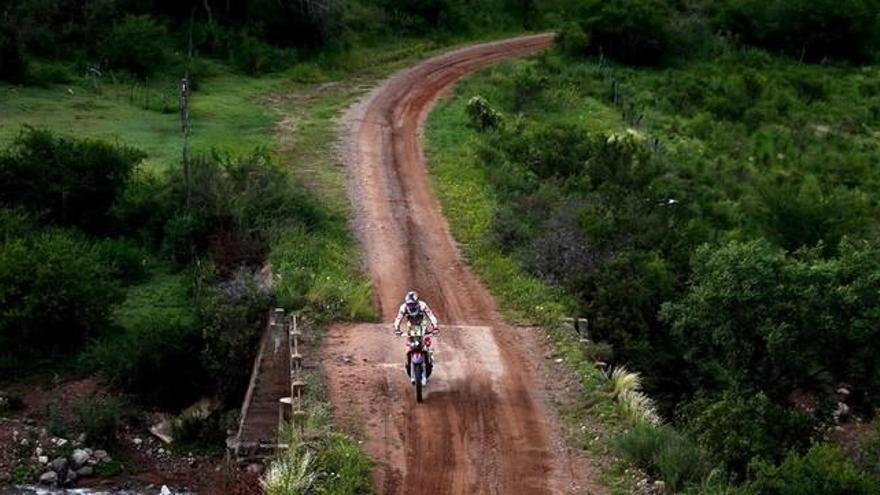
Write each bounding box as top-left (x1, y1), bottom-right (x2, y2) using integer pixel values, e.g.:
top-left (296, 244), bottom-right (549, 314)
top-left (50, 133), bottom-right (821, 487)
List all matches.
top-left (0, 230), bottom-right (122, 374)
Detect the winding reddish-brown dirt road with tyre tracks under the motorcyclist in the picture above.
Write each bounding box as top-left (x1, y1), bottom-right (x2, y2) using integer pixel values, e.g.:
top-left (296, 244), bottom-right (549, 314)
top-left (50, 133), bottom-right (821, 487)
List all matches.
top-left (323, 35), bottom-right (601, 494)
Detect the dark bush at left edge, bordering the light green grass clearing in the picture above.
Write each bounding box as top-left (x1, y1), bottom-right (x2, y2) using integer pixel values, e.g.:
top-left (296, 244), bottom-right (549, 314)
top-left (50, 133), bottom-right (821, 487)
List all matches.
top-left (0, 127), bottom-right (145, 233)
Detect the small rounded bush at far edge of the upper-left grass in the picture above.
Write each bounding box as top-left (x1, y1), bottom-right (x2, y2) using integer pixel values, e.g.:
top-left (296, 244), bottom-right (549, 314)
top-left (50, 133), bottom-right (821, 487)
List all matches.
top-left (104, 15), bottom-right (168, 79)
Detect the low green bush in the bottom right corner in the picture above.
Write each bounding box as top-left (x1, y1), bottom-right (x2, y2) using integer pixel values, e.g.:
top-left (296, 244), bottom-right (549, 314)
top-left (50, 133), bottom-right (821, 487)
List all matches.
top-left (747, 444), bottom-right (880, 495)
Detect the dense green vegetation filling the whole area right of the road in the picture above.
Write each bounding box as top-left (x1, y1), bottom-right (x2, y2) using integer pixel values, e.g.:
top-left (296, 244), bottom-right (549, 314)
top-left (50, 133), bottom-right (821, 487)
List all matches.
top-left (432, 0), bottom-right (880, 493)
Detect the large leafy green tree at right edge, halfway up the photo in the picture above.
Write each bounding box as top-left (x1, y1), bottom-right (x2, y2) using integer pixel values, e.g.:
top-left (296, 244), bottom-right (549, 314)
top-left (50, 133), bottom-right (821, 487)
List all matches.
top-left (662, 241), bottom-right (880, 403)
